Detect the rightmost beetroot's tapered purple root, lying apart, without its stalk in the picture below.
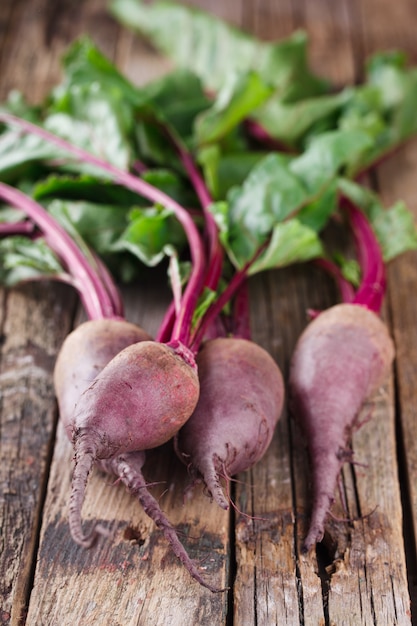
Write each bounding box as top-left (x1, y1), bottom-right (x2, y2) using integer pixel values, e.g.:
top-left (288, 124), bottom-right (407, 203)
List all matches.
top-left (289, 304), bottom-right (394, 551)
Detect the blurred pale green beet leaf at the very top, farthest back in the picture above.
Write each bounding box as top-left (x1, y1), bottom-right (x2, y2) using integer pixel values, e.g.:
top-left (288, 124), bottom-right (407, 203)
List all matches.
top-left (110, 0), bottom-right (328, 100)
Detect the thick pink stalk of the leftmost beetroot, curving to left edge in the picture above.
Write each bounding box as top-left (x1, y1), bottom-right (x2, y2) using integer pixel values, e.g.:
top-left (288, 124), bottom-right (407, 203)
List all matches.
top-left (0, 182), bottom-right (115, 319)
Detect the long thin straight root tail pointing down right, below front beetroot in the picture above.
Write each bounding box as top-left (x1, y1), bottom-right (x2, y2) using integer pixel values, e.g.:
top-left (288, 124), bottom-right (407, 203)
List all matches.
top-left (112, 453), bottom-right (226, 593)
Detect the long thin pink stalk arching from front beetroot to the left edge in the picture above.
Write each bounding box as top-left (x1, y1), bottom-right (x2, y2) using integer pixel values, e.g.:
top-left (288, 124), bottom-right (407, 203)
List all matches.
top-left (0, 113), bottom-right (205, 345)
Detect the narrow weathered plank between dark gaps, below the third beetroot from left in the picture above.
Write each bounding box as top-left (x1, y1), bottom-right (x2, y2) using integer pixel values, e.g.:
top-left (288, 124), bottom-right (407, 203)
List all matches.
top-left (234, 275), bottom-right (299, 624)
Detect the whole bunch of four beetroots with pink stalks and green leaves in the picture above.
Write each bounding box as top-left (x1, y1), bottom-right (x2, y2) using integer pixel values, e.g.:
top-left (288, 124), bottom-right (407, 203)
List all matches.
top-left (0, 7), bottom-right (417, 591)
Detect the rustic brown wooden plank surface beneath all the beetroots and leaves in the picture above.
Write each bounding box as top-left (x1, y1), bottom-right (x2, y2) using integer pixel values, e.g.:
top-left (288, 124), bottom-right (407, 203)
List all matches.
top-left (0, 0), bottom-right (417, 626)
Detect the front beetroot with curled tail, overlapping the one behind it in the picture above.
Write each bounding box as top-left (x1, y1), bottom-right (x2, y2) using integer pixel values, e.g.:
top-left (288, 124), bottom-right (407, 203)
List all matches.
top-left (55, 341), bottom-right (199, 547)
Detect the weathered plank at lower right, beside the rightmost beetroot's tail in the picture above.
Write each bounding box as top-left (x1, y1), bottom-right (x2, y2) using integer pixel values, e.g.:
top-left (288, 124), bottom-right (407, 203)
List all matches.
top-left (327, 370), bottom-right (410, 625)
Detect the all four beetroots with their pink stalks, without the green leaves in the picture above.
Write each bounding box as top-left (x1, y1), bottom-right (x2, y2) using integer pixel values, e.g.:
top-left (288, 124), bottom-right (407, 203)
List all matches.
top-left (0, 109), bottom-right (404, 591)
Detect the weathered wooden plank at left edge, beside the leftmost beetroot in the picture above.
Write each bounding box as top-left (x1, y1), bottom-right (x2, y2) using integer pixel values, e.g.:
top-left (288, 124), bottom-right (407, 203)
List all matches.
top-left (0, 285), bottom-right (77, 624)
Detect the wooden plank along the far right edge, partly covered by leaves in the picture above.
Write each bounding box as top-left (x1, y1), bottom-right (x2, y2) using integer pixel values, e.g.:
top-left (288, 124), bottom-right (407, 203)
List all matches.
top-left (359, 0), bottom-right (417, 619)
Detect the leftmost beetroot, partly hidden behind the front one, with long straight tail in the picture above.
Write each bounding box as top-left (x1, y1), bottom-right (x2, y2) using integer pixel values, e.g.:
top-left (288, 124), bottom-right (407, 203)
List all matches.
top-left (54, 319), bottom-right (228, 592)
